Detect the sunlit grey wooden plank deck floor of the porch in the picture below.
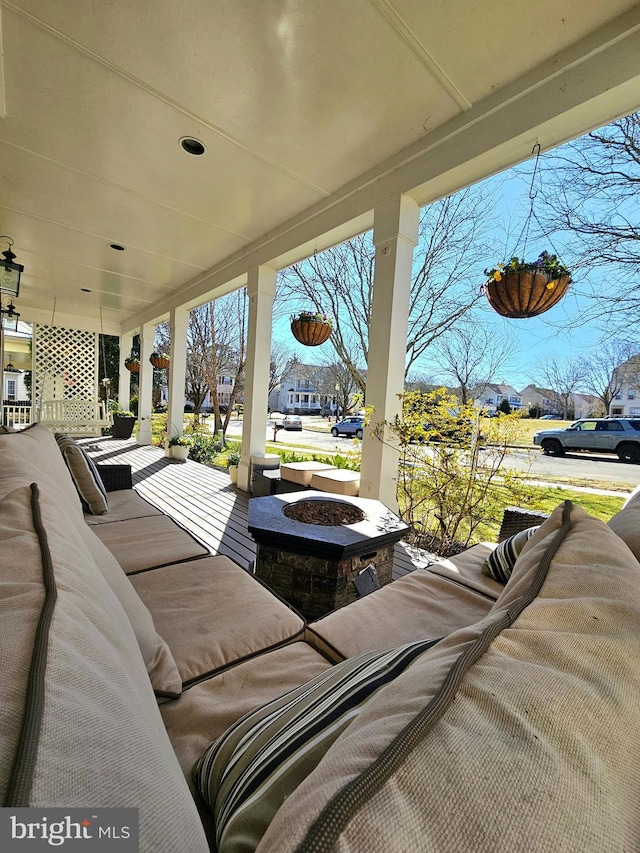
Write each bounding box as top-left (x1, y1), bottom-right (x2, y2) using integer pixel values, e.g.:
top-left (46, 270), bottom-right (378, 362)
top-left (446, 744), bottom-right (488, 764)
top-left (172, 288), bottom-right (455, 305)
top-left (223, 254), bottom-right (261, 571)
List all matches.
top-left (80, 437), bottom-right (429, 578)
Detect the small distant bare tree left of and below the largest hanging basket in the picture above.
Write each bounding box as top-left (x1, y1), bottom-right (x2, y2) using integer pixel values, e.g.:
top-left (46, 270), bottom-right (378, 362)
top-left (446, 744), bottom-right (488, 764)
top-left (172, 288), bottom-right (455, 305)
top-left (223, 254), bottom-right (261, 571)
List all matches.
top-left (434, 315), bottom-right (516, 406)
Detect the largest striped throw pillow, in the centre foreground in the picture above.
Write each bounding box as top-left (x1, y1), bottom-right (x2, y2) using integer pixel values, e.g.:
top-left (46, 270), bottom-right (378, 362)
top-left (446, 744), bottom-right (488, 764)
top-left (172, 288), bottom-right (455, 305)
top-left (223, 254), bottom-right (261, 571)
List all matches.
top-left (193, 640), bottom-right (438, 853)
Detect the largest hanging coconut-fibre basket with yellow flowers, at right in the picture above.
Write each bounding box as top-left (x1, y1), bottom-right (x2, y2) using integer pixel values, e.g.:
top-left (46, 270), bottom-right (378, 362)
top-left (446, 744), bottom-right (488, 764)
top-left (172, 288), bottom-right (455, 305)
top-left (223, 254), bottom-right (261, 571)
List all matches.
top-left (484, 252), bottom-right (571, 319)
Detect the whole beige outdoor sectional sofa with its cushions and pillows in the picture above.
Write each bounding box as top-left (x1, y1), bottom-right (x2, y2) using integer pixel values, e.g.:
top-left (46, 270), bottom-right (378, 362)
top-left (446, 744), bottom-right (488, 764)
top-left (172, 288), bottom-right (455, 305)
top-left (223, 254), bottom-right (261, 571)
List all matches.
top-left (0, 425), bottom-right (640, 853)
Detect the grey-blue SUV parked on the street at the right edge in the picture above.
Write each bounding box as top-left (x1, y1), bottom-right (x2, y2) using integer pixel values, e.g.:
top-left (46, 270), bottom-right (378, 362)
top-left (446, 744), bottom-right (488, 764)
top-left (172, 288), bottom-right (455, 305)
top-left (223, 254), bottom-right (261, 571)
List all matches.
top-left (533, 418), bottom-right (640, 462)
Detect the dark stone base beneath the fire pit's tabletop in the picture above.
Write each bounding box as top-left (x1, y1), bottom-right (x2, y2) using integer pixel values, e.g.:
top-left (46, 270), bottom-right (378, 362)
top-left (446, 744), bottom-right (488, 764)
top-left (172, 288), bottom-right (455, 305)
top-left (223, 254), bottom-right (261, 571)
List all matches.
top-left (256, 545), bottom-right (394, 620)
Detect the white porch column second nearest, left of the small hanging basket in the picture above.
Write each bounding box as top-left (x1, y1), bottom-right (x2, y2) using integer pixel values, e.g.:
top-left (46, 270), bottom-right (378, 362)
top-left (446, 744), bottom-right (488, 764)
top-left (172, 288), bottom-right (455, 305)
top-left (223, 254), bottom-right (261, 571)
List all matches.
top-left (238, 266), bottom-right (276, 492)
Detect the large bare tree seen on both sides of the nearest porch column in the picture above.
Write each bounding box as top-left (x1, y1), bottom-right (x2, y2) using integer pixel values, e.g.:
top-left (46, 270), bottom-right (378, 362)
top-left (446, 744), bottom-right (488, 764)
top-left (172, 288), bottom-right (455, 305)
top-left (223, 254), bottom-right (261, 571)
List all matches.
top-left (277, 185), bottom-right (493, 394)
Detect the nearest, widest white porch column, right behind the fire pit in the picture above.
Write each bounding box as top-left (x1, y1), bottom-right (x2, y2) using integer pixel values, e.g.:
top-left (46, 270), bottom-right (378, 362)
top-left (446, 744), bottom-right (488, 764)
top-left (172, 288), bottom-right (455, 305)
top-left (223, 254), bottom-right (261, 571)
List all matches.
top-left (360, 196), bottom-right (420, 511)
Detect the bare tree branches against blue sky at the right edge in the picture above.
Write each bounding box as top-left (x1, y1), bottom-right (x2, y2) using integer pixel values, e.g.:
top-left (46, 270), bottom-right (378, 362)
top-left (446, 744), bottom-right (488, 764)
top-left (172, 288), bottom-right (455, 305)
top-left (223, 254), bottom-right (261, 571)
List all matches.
top-left (540, 113), bottom-right (640, 329)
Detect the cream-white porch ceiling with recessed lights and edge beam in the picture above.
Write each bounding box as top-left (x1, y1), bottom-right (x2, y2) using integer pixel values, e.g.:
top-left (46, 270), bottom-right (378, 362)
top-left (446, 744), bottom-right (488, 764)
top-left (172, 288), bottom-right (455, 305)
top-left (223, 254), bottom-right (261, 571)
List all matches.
top-left (0, 0), bottom-right (640, 333)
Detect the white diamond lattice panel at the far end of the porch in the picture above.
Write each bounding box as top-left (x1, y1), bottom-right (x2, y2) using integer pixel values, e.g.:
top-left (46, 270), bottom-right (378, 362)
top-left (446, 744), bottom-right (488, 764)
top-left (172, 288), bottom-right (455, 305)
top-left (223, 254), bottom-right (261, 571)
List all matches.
top-left (33, 324), bottom-right (98, 410)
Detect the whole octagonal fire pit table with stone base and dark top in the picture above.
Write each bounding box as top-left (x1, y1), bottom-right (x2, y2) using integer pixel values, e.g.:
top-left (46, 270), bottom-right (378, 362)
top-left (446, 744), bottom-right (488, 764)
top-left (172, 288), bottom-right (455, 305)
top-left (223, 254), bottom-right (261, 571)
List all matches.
top-left (249, 491), bottom-right (408, 619)
